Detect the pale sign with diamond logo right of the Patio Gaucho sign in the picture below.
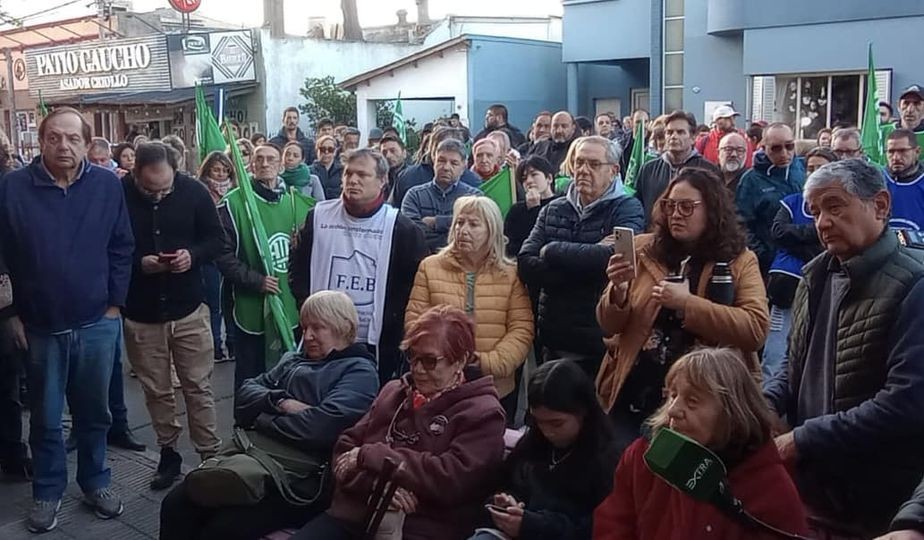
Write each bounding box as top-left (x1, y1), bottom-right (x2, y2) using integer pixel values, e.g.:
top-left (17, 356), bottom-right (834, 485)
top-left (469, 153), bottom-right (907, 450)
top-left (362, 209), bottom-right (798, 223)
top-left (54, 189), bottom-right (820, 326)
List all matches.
top-left (167, 30), bottom-right (256, 88)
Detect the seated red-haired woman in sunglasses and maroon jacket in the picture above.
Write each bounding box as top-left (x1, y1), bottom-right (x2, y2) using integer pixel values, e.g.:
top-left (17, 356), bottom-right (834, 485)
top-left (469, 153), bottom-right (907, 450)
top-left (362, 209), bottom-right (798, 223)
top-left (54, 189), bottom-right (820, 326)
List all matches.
top-left (292, 306), bottom-right (504, 540)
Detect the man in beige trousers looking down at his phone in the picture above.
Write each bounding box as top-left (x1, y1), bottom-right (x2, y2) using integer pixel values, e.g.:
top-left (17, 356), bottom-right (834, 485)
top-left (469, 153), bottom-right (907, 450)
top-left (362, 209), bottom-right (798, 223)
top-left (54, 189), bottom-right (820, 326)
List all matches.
top-left (122, 142), bottom-right (224, 490)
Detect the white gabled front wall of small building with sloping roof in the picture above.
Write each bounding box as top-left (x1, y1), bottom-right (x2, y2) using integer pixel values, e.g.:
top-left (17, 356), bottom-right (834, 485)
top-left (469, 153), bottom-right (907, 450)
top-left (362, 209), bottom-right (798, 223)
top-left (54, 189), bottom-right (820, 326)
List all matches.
top-left (356, 45), bottom-right (469, 146)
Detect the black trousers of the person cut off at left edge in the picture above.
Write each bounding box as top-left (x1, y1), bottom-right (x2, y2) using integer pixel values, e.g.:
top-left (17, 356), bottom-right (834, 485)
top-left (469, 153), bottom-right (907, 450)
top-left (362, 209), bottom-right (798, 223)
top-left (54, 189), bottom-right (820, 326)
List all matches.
top-left (0, 344), bottom-right (28, 464)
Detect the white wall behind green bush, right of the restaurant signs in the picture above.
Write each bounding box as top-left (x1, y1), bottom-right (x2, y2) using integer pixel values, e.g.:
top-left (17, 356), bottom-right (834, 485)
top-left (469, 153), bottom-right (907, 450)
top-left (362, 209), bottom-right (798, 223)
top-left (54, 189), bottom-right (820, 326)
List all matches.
top-left (251, 29), bottom-right (421, 136)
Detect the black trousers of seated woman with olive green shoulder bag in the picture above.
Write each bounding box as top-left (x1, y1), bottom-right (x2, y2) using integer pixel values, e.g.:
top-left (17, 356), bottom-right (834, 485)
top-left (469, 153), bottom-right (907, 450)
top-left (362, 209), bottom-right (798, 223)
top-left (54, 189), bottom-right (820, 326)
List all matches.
top-left (160, 476), bottom-right (330, 540)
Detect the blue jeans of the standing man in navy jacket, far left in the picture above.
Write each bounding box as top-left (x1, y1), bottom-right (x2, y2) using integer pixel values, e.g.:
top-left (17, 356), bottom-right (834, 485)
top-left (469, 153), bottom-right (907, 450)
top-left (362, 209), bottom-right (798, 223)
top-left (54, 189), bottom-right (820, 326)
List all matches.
top-left (27, 317), bottom-right (122, 501)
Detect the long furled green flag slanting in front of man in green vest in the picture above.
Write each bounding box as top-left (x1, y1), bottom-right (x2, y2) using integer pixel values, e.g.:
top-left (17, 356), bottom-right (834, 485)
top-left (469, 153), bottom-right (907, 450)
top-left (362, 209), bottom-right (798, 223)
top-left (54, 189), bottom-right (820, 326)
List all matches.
top-left (222, 122), bottom-right (295, 358)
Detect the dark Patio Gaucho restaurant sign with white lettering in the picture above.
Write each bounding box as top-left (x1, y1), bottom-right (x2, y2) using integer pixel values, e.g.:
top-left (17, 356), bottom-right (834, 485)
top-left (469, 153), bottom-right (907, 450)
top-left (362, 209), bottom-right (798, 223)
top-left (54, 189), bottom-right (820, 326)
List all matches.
top-left (26, 36), bottom-right (171, 98)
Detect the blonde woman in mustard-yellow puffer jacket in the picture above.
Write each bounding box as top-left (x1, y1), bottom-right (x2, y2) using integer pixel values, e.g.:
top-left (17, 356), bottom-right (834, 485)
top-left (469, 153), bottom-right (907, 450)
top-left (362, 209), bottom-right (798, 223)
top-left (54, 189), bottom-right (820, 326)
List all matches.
top-left (404, 197), bottom-right (534, 424)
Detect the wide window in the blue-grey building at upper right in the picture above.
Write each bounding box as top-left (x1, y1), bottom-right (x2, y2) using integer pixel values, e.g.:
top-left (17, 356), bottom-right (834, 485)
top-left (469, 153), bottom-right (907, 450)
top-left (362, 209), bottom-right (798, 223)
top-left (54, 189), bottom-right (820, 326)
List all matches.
top-left (751, 70), bottom-right (892, 139)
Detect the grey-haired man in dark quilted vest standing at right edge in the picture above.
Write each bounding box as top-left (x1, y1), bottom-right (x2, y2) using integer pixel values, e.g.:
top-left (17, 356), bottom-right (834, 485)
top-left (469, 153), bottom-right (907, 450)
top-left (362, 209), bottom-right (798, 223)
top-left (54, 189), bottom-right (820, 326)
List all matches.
top-left (765, 159), bottom-right (924, 538)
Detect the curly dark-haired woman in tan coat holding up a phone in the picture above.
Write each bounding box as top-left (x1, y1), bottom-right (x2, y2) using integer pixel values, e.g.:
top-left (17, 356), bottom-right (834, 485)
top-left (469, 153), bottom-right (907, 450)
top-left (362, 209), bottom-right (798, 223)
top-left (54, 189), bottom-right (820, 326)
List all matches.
top-left (597, 167), bottom-right (770, 448)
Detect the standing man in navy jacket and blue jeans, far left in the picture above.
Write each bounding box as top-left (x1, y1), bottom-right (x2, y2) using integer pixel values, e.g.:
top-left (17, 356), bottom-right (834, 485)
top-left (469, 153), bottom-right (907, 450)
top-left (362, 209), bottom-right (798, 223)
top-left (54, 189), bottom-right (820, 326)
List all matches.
top-left (0, 107), bottom-right (134, 532)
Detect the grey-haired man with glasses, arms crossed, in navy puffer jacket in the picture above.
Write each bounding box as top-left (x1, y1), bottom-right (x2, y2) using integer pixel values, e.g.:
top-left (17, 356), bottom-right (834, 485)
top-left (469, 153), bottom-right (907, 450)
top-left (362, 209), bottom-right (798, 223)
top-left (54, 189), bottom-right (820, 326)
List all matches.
top-left (518, 136), bottom-right (645, 378)
